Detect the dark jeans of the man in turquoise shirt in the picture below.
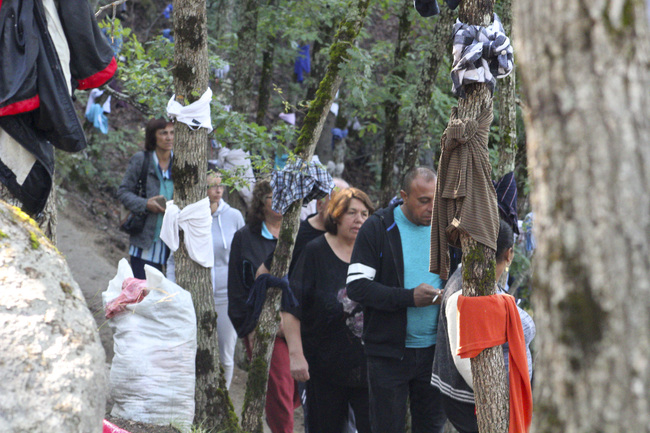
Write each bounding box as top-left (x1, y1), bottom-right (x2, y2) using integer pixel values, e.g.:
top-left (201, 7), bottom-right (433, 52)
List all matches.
top-left (368, 345), bottom-right (445, 433)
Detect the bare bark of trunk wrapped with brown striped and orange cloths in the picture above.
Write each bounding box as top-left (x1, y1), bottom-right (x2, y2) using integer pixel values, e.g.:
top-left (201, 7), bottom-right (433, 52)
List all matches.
top-left (450, 0), bottom-right (509, 433)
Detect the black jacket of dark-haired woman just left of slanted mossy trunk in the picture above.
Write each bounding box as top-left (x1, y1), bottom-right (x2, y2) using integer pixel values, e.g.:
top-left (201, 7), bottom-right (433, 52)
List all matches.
top-left (228, 224), bottom-right (277, 338)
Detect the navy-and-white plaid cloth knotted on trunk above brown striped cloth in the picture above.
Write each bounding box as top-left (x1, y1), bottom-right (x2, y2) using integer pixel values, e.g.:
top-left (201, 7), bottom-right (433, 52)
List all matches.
top-left (451, 14), bottom-right (513, 97)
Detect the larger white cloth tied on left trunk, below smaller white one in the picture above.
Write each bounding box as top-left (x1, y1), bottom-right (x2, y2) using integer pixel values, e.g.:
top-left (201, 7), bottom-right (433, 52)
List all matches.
top-left (160, 197), bottom-right (214, 268)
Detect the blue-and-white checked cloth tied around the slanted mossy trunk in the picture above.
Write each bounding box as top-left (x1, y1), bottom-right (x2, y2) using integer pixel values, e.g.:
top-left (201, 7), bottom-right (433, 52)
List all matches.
top-left (271, 159), bottom-right (334, 215)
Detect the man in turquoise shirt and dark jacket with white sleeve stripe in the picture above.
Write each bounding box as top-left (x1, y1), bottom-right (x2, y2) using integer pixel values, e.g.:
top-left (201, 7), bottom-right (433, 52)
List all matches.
top-left (347, 167), bottom-right (445, 433)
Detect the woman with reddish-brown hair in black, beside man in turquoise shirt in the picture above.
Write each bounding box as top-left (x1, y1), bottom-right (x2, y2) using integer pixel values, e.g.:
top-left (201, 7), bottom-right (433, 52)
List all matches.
top-left (288, 188), bottom-right (374, 433)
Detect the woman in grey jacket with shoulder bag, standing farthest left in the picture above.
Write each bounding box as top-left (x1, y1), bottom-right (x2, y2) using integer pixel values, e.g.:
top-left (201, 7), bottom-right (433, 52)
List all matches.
top-left (117, 119), bottom-right (174, 279)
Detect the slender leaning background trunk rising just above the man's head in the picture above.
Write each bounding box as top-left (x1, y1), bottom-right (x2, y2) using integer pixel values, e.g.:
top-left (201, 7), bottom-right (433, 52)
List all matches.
top-left (401, 6), bottom-right (455, 173)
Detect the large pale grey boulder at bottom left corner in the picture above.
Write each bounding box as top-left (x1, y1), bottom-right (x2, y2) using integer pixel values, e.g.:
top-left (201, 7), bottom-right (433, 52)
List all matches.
top-left (0, 201), bottom-right (106, 433)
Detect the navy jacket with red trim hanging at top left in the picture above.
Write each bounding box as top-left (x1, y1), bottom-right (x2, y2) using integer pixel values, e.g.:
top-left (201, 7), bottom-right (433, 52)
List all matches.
top-left (0, 0), bottom-right (117, 152)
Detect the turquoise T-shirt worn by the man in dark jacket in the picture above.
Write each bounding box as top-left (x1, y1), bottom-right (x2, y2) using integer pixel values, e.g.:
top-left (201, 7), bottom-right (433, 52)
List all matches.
top-left (393, 206), bottom-right (442, 348)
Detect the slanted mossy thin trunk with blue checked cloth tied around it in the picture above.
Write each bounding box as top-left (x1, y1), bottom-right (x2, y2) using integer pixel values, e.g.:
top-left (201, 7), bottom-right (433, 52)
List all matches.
top-left (242, 0), bottom-right (370, 432)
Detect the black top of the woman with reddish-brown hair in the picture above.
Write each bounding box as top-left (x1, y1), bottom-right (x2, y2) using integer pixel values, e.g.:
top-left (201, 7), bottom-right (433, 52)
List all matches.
top-left (291, 236), bottom-right (367, 387)
